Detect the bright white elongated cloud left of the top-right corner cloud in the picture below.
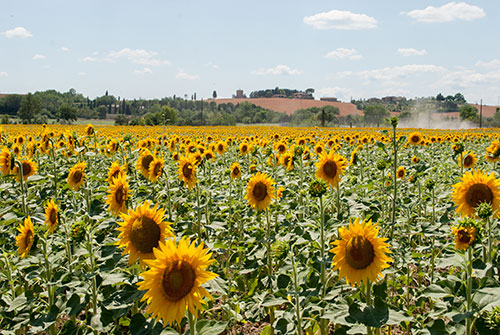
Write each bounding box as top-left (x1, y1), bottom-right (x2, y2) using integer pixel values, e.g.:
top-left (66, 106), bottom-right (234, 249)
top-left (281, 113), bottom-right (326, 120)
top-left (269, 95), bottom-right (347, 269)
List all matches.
top-left (304, 9), bottom-right (377, 30)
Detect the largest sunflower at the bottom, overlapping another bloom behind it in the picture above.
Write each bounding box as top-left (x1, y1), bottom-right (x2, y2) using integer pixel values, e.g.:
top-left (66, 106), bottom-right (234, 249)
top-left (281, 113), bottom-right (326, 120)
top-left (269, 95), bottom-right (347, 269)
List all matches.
top-left (137, 238), bottom-right (217, 325)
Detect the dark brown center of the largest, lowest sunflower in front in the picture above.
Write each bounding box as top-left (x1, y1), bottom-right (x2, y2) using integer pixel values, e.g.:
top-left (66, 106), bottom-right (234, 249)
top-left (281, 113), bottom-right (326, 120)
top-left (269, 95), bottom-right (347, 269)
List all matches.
top-left (162, 261), bottom-right (196, 302)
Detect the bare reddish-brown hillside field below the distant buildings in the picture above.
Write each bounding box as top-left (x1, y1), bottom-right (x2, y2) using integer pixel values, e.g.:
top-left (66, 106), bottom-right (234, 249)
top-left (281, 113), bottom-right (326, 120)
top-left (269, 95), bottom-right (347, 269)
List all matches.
top-left (207, 98), bottom-right (363, 116)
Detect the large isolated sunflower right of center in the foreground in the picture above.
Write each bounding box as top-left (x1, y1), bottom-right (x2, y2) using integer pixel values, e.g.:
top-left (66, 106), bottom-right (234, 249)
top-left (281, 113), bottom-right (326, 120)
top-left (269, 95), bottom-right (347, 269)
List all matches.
top-left (330, 218), bottom-right (393, 285)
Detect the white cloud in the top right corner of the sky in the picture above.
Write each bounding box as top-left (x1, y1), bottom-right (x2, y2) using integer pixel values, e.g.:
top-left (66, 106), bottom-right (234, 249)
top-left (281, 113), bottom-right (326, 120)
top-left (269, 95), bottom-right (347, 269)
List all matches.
top-left (401, 2), bottom-right (486, 23)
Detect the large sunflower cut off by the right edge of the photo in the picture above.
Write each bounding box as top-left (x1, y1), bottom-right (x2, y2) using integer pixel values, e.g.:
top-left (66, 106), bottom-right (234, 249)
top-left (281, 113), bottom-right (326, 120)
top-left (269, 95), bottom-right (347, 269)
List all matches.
top-left (452, 170), bottom-right (500, 217)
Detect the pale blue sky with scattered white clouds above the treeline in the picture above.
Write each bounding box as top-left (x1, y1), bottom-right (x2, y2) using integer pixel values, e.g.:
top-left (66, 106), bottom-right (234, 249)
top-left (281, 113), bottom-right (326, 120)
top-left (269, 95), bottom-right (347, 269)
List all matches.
top-left (0, 0), bottom-right (500, 104)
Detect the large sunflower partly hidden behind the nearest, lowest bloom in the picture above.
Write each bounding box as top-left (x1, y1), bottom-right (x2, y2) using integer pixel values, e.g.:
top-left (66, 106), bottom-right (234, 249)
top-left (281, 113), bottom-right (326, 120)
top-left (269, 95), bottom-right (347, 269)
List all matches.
top-left (116, 201), bottom-right (174, 266)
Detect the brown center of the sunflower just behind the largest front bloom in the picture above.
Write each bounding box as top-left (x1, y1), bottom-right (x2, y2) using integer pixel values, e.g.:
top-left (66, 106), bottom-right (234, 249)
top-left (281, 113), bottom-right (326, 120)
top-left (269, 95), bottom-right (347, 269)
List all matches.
top-left (130, 217), bottom-right (161, 254)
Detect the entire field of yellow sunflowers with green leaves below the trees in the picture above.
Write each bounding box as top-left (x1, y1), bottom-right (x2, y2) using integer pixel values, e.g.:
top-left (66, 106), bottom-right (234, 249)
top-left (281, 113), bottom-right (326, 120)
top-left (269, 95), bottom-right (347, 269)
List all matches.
top-left (0, 122), bottom-right (500, 335)
